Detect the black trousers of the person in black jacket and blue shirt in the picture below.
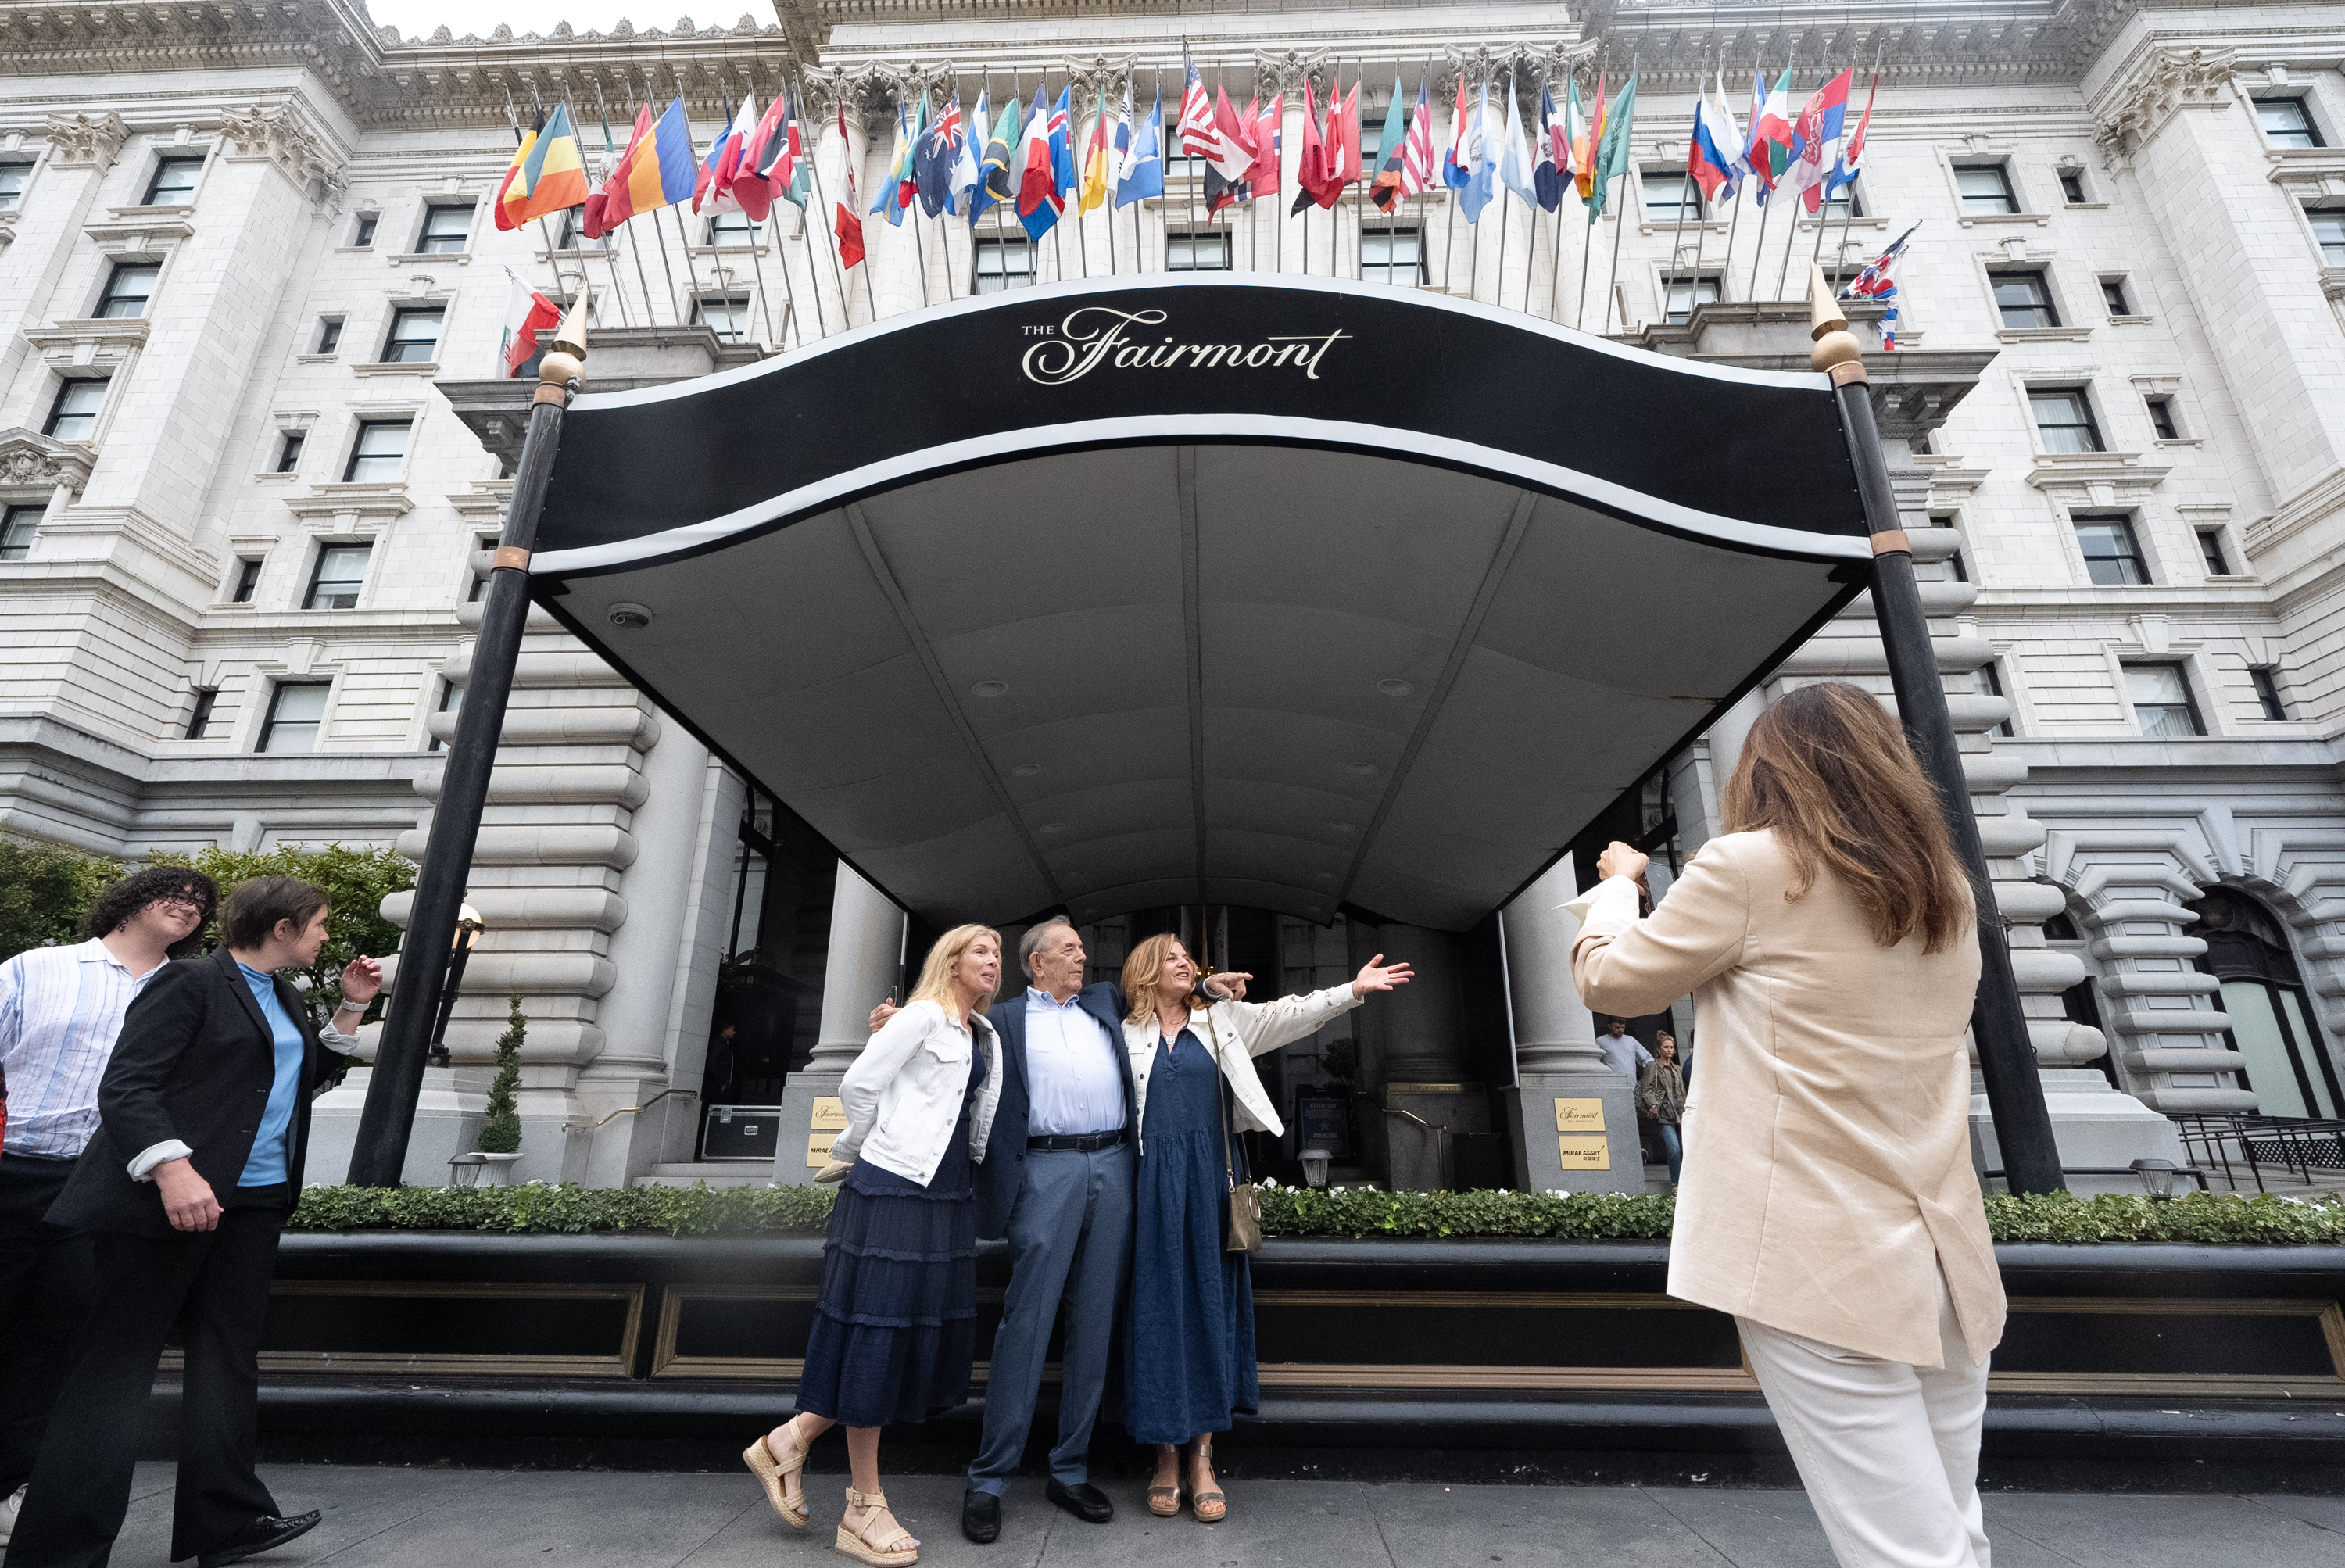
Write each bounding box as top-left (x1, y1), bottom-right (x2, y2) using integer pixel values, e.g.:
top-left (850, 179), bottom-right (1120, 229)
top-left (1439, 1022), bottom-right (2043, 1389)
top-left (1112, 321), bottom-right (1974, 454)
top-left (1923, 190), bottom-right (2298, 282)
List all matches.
top-left (7, 1186), bottom-right (288, 1568)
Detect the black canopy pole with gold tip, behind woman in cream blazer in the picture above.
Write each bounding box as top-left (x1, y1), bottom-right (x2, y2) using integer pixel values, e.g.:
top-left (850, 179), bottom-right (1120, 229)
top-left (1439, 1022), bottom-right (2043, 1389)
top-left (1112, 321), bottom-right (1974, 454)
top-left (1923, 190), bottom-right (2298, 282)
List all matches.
top-left (1808, 263), bottom-right (2068, 1193)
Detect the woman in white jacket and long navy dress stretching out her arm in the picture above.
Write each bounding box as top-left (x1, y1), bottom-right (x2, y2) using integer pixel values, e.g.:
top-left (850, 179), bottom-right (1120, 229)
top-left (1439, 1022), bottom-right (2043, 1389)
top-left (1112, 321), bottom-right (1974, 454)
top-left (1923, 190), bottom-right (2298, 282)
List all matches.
top-left (1123, 935), bottom-right (1409, 1523)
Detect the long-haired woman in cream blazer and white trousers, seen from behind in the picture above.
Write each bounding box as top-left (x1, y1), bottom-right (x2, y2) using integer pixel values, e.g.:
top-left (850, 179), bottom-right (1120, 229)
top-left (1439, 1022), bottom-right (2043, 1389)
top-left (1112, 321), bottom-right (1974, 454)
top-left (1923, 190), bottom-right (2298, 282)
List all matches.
top-left (1571, 682), bottom-right (2005, 1568)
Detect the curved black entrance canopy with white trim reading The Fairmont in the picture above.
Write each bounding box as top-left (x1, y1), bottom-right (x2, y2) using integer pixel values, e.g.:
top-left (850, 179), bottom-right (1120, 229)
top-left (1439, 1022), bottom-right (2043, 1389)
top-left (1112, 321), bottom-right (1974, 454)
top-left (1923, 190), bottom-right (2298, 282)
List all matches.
top-left (532, 274), bottom-right (1871, 928)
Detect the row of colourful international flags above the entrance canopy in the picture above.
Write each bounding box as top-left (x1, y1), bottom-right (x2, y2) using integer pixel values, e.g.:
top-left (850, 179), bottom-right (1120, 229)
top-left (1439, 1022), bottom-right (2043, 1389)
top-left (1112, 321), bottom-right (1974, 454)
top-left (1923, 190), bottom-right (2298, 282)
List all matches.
top-left (481, 61), bottom-right (1904, 353)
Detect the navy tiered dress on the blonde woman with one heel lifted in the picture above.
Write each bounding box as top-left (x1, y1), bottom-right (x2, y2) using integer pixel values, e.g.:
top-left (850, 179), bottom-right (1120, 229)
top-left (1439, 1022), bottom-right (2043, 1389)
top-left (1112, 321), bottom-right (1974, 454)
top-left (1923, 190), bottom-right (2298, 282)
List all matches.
top-left (797, 1022), bottom-right (985, 1427)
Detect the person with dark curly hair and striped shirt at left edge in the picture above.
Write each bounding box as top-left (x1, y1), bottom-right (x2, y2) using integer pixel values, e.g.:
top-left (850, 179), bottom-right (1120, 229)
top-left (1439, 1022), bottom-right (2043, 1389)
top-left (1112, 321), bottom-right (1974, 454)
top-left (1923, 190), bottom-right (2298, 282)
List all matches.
top-left (0, 865), bottom-right (220, 1547)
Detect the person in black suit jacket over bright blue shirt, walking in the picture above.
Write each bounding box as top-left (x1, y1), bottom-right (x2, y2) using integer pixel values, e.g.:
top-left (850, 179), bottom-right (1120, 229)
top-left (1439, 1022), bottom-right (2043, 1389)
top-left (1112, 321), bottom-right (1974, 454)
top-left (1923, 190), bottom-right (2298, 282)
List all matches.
top-left (7, 876), bottom-right (382, 1568)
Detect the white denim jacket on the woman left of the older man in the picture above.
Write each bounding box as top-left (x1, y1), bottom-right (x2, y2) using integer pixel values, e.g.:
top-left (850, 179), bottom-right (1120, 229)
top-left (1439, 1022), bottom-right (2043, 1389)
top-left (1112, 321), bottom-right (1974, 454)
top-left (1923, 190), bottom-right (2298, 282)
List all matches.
top-left (830, 1001), bottom-right (1001, 1186)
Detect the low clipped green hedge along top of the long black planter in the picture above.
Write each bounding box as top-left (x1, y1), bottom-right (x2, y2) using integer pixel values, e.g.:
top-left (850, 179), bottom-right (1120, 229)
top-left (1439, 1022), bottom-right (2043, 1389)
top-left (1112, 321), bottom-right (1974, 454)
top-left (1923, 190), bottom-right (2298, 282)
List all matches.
top-left (288, 1183), bottom-right (2345, 1244)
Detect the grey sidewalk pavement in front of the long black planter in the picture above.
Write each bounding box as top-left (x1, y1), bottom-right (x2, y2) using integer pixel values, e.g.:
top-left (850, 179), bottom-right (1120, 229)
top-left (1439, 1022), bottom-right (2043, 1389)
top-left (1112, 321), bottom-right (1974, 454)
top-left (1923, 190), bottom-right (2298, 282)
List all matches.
top-left (77, 1462), bottom-right (2345, 1568)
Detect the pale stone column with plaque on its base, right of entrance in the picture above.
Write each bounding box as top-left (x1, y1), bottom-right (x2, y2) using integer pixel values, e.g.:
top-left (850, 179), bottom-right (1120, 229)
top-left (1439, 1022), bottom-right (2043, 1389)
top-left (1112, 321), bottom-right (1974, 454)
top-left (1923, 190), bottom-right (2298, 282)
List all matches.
top-left (1498, 855), bottom-right (1644, 1193)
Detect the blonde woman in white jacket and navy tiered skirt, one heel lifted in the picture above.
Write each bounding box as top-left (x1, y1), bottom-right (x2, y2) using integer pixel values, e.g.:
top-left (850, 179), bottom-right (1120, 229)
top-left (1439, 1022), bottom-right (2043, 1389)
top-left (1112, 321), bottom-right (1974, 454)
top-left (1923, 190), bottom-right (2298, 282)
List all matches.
top-left (741, 925), bottom-right (1001, 1568)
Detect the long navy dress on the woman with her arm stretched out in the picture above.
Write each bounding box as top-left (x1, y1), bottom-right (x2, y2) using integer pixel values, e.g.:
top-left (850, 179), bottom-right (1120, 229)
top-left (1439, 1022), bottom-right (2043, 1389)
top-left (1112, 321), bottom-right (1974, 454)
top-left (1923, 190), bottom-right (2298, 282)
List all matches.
top-left (1123, 1029), bottom-right (1262, 1444)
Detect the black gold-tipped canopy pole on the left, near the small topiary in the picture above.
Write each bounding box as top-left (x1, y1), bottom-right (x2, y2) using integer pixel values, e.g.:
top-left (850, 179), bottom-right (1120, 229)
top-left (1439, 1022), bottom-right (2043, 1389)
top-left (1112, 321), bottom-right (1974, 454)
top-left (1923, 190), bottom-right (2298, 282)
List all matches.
top-left (349, 284), bottom-right (586, 1186)
